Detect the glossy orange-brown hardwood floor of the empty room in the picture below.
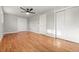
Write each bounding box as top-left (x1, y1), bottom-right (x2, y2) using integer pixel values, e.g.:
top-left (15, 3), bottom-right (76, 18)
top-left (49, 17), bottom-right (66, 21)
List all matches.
top-left (0, 32), bottom-right (79, 52)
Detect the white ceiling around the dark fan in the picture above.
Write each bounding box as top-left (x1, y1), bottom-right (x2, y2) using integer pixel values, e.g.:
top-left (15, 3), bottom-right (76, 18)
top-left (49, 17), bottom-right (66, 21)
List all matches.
top-left (3, 6), bottom-right (67, 17)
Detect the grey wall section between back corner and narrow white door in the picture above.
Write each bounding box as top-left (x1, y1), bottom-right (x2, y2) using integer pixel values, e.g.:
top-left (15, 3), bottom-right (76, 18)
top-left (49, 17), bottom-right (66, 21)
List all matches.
top-left (28, 16), bottom-right (39, 33)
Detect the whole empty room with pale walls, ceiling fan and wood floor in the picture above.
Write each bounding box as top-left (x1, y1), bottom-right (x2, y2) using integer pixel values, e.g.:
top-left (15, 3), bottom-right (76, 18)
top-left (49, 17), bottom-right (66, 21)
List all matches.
top-left (0, 6), bottom-right (79, 52)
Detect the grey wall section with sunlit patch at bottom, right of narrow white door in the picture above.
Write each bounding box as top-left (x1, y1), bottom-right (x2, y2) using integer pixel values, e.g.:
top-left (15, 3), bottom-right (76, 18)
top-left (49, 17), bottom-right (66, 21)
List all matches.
top-left (46, 10), bottom-right (55, 37)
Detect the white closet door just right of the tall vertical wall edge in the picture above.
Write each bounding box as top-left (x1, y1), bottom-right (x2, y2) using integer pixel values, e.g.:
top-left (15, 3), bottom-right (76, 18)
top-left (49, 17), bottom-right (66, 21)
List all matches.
top-left (55, 10), bottom-right (65, 38)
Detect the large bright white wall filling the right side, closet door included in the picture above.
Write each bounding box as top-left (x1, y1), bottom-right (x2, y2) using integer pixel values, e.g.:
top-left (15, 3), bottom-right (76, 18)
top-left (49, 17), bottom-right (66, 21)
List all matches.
top-left (56, 7), bottom-right (79, 43)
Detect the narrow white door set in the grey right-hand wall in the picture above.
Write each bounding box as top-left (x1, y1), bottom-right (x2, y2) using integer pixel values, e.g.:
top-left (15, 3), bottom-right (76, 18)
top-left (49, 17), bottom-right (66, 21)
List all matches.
top-left (39, 14), bottom-right (46, 34)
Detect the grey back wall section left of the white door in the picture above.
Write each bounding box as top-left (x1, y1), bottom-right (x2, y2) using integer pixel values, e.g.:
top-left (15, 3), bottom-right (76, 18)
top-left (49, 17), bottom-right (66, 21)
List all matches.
top-left (4, 14), bottom-right (17, 33)
